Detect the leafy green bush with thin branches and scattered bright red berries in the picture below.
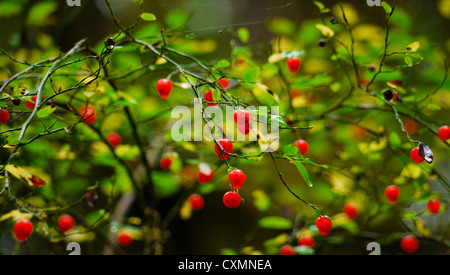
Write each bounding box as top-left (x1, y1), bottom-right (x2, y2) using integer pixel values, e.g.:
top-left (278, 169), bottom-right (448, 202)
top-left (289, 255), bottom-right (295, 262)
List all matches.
top-left (0, 0), bottom-right (450, 255)
